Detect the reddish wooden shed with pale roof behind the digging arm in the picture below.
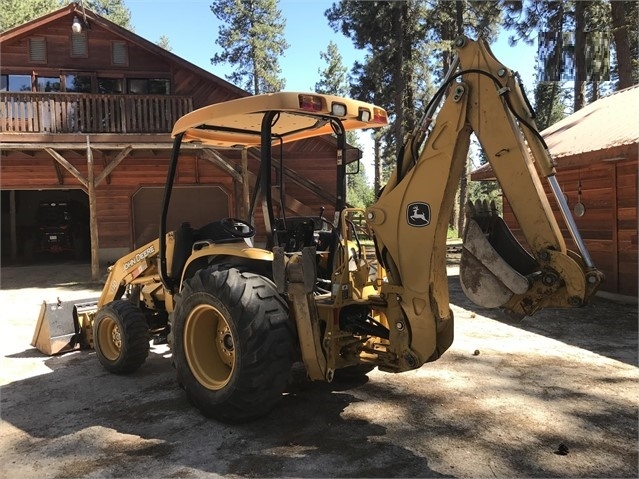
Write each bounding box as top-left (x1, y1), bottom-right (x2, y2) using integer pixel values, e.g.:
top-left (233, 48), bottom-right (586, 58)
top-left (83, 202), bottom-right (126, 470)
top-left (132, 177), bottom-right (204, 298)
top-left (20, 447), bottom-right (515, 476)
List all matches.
top-left (471, 85), bottom-right (639, 297)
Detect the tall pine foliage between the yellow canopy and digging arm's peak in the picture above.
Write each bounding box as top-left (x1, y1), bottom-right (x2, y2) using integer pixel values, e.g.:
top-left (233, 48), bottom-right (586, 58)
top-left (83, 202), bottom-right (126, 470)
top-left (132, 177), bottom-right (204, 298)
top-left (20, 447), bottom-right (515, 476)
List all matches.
top-left (325, 0), bottom-right (500, 202)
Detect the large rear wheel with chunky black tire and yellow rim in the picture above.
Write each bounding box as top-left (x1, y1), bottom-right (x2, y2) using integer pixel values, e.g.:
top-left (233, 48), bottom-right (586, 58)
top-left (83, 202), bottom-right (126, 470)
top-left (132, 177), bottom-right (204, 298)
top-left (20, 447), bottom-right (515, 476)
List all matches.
top-left (169, 266), bottom-right (294, 422)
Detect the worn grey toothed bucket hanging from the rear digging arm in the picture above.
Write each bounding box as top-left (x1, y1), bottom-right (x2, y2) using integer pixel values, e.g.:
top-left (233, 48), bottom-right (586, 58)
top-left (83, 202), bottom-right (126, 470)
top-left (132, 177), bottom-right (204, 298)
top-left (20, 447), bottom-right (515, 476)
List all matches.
top-left (459, 202), bottom-right (537, 308)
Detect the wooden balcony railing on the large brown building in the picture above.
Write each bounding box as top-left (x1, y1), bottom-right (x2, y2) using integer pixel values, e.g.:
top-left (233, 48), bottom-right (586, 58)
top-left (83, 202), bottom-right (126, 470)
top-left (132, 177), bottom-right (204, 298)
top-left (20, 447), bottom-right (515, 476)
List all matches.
top-left (0, 92), bottom-right (193, 133)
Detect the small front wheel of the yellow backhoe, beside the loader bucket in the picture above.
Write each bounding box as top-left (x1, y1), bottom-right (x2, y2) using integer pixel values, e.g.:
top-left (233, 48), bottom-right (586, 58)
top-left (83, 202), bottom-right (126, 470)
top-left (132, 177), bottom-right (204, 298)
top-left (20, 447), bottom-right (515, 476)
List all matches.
top-left (93, 299), bottom-right (150, 374)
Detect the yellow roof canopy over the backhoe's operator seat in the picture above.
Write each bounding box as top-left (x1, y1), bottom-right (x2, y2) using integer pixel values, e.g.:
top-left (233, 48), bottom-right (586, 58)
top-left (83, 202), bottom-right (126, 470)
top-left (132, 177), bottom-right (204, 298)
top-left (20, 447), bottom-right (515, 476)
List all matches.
top-left (171, 92), bottom-right (388, 148)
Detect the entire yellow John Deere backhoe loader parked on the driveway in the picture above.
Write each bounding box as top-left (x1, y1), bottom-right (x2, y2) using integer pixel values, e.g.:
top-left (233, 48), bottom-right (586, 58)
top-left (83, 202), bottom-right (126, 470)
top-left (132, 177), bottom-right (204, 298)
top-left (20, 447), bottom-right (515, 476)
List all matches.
top-left (34, 37), bottom-right (603, 421)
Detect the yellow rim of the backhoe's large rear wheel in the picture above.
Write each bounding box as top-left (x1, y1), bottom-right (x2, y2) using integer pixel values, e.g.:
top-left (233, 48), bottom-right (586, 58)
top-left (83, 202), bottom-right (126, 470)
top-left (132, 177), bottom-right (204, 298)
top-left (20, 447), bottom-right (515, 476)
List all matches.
top-left (184, 305), bottom-right (235, 390)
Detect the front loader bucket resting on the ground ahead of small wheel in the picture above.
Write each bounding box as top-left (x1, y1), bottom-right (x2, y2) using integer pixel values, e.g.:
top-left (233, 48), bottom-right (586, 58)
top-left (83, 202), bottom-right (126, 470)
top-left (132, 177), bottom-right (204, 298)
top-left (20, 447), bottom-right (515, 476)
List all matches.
top-left (31, 298), bottom-right (97, 356)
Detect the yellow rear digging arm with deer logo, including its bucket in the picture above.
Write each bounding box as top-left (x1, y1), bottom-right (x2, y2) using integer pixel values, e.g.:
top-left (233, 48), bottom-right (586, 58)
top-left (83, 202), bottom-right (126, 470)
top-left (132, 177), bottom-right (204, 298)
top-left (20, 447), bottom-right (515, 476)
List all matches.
top-left (367, 37), bottom-right (603, 367)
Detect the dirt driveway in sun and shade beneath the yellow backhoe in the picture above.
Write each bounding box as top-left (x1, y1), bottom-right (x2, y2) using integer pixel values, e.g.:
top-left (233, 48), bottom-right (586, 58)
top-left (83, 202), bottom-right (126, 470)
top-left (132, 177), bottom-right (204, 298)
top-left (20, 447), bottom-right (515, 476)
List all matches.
top-left (0, 264), bottom-right (639, 479)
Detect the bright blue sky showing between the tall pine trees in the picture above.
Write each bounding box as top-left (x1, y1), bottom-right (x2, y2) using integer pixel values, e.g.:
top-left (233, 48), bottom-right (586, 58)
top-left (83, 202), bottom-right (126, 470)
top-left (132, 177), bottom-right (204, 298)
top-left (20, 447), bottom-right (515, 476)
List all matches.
top-left (126, 0), bottom-right (535, 91)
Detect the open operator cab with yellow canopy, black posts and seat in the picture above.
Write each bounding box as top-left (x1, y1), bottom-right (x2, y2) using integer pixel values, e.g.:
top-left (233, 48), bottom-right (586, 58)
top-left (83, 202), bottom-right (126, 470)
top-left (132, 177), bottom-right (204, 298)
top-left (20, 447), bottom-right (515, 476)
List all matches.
top-left (160, 92), bottom-right (388, 289)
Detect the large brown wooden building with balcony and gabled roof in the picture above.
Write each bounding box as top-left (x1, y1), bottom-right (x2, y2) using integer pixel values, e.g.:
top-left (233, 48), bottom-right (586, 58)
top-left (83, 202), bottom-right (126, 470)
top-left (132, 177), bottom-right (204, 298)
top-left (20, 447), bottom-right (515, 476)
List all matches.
top-left (0, 3), bottom-right (350, 278)
